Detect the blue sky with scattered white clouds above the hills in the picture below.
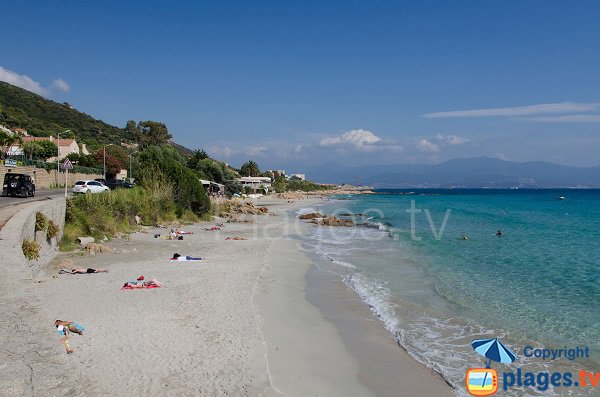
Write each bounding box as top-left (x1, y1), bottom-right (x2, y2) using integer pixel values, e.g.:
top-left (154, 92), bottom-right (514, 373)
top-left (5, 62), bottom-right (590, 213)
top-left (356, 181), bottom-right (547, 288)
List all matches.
top-left (0, 0), bottom-right (600, 172)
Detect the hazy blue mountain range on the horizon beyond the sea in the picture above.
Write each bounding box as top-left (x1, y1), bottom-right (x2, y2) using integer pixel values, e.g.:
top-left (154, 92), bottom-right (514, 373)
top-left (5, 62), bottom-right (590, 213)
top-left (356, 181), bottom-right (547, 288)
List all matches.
top-left (306, 157), bottom-right (600, 188)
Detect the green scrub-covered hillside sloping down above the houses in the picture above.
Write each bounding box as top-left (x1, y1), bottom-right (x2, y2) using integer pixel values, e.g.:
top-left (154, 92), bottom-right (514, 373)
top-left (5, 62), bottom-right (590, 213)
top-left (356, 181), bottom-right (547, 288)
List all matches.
top-left (0, 81), bottom-right (133, 147)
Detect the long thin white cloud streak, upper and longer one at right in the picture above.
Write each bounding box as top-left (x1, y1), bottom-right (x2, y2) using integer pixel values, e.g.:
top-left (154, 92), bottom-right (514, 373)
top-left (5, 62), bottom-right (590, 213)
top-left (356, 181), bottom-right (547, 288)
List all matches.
top-left (423, 102), bottom-right (600, 119)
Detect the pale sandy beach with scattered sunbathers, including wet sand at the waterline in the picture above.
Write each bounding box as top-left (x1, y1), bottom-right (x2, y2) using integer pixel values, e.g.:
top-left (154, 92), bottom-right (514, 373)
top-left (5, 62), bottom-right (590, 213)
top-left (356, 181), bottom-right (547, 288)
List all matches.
top-left (8, 199), bottom-right (452, 396)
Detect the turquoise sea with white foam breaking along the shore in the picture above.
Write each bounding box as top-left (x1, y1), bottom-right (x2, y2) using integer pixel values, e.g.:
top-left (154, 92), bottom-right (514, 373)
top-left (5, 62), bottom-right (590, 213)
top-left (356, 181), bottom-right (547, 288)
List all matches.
top-left (299, 189), bottom-right (600, 396)
